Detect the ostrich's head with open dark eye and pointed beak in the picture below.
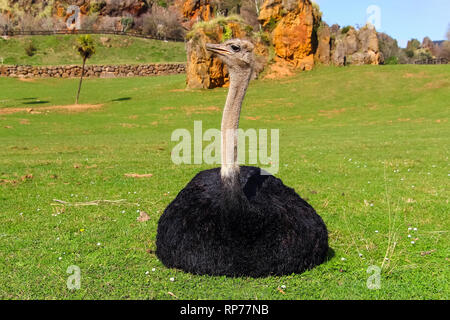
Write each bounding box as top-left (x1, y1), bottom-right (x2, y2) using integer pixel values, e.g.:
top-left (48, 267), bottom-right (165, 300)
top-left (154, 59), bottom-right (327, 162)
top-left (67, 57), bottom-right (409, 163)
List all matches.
top-left (206, 39), bottom-right (254, 73)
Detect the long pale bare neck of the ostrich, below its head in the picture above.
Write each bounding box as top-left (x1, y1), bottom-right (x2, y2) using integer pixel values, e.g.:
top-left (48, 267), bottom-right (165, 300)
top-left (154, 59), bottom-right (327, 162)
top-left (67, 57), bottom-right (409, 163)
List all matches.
top-left (220, 68), bottom-right (252, 184)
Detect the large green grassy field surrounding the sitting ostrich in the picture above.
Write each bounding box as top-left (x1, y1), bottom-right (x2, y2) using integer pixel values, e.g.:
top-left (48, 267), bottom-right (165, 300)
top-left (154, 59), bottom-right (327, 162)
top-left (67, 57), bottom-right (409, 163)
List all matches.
top-left (0, 65), bottom-right (450, 299)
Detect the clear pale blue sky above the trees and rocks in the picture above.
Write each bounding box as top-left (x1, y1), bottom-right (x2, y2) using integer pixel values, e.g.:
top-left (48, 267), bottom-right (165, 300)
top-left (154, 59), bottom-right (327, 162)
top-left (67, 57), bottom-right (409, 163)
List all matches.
top-left (315, 0), bottom-right (450, 46)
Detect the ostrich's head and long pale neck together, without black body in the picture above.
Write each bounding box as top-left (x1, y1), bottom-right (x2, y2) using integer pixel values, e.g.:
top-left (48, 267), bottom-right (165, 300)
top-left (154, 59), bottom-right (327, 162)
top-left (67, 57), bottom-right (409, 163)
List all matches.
top-left (206, 39), bottom-right (254, 186)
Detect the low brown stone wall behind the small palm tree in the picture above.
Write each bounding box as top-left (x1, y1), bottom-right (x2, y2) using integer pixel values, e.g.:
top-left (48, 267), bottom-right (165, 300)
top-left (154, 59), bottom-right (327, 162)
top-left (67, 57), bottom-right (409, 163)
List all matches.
top-left (0, 64), bottom-right (186, 78)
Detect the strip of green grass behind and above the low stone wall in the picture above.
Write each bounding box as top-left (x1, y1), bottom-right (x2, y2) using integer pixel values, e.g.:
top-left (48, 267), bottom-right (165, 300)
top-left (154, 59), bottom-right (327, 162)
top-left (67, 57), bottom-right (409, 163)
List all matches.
top-left (0, 35), bottom-right (186, 65)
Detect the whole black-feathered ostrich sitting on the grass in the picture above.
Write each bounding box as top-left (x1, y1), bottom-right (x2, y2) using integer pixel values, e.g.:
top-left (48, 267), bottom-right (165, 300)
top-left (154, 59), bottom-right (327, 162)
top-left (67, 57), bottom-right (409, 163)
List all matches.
top-left (156, 39), bottom-right (328, 277)
